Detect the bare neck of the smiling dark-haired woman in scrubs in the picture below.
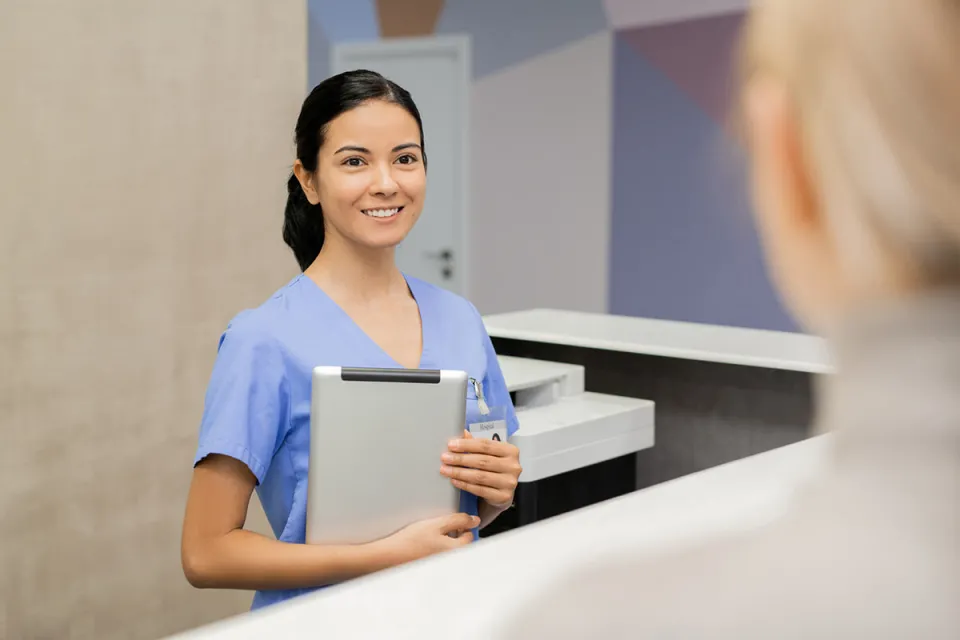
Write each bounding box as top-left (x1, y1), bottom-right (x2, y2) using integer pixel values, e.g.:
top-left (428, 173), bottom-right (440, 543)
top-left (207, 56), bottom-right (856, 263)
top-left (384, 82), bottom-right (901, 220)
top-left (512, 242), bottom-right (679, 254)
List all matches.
top-left (304, 236), bottom-right (407, 300)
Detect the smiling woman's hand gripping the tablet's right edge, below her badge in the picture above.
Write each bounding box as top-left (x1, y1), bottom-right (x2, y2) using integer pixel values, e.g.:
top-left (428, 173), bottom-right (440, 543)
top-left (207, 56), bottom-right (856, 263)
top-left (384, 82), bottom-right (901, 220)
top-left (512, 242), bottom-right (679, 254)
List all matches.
top-left (440, 431), bottom-right (523, 509)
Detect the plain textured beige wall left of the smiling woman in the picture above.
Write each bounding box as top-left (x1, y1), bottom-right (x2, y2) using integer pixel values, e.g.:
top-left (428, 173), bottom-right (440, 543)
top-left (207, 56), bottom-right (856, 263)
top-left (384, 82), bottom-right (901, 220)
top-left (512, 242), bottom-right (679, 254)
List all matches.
top-left (0, 0), bottom-right (306, 639)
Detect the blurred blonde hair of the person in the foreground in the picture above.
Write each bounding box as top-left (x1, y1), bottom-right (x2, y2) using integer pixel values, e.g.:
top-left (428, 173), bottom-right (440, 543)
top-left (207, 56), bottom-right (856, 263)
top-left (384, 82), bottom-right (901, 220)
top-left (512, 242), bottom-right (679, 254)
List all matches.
top-left (741, 0), bottom-right (960, 282)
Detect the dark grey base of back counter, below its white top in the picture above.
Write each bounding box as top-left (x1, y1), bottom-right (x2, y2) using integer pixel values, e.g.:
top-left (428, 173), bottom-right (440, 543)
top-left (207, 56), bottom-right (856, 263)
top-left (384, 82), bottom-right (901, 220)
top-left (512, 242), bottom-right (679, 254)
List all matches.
top-left (485, 339), bottom-right (813, 534)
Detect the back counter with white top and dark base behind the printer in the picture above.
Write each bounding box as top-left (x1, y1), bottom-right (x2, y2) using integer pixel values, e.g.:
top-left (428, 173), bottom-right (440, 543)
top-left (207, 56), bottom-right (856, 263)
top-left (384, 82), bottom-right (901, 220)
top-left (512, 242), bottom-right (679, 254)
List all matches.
top-left (485, 309), bottom-right (833, 494)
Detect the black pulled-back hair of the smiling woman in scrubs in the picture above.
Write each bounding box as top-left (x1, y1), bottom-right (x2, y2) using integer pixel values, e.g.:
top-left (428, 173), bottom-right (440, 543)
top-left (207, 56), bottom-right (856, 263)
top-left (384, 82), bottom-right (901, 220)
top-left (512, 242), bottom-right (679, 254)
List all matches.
top-left (283, 69), bottom-right (427, 270)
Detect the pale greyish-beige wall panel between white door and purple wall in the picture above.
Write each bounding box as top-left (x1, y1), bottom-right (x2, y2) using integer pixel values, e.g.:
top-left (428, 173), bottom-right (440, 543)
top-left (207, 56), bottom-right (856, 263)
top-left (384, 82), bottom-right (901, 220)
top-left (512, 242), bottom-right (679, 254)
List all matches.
top-left (470, 32), bottom-right (613, 314)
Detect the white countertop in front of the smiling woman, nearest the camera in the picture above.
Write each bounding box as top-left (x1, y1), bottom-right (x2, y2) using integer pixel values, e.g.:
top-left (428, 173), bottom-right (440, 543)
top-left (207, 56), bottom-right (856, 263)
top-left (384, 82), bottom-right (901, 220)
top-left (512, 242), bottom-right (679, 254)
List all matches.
top-left (169, 436), bottom-right (829, 640)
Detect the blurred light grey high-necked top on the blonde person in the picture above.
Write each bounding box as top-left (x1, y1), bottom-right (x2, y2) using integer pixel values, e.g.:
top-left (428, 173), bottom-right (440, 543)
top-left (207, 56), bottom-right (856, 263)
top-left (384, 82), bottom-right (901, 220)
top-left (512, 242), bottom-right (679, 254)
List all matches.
top-left (504, 291), bottom-right (960, 640)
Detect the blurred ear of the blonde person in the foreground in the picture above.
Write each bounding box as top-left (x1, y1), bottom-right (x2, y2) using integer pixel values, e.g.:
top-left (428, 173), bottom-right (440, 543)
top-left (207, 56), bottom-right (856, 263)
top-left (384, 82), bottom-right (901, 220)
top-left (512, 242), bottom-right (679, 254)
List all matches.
top-left (745, 78), bottom-right (821, 231)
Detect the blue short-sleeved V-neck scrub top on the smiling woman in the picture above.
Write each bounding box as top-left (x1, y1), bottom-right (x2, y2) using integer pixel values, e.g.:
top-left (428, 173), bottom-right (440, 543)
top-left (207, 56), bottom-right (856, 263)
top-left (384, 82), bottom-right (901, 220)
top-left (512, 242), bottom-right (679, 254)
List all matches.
top-left (194, 274), bottom-right (518, 609)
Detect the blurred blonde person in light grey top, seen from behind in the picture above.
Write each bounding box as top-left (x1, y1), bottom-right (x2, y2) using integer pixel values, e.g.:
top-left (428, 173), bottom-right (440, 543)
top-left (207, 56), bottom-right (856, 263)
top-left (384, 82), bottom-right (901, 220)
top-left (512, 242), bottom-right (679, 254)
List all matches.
top-left (503, 0), bottom-right (960, 639)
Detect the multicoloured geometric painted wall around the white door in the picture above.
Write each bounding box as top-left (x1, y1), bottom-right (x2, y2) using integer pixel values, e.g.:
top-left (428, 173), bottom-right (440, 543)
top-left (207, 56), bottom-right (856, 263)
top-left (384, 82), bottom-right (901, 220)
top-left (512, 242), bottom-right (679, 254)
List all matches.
top-left (307, 5), bottom-right (797, 331)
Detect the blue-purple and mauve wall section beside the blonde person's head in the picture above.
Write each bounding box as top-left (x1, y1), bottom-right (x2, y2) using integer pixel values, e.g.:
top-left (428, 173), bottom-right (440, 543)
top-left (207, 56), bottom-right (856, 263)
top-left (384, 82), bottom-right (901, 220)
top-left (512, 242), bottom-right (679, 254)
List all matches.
top-left (610, 16), bottom-right (797, 331)
